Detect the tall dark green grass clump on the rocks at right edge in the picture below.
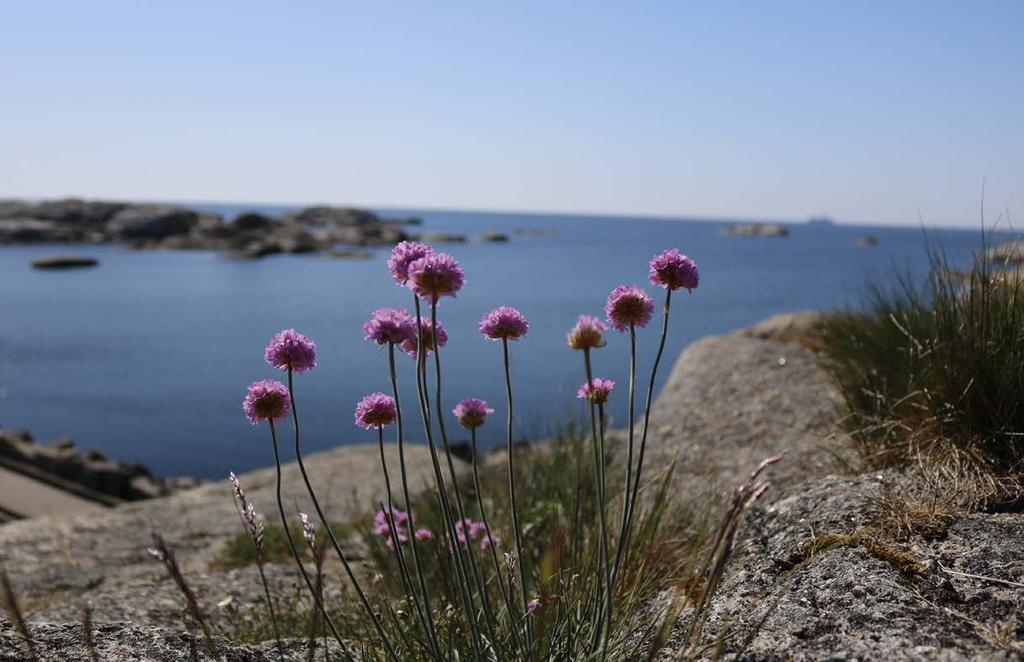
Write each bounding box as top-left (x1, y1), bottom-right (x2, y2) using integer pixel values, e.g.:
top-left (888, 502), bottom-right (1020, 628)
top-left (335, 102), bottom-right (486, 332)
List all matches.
top-left (824, 236), bottom-right (1024, 472)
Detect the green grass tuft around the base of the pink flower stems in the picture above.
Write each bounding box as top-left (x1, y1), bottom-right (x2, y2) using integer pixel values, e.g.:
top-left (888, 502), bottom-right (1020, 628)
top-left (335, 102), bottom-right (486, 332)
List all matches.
top-left (217, 433), bottom-right (741, 660)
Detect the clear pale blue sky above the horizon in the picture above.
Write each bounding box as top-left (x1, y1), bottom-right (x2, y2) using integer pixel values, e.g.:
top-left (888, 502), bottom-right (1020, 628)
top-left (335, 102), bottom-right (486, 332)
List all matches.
top-left (0, 0), bottom-right (1024, 224)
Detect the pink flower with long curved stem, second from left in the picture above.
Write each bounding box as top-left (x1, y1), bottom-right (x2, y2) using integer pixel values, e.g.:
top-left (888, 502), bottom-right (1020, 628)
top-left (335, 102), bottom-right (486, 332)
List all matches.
top-left (264, 329), bottom-right (399, 662)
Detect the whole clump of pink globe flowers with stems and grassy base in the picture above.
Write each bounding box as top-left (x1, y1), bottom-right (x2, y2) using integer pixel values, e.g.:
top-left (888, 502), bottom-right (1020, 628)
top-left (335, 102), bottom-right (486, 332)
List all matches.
top-left (136, 242), bottom-right (775, 662)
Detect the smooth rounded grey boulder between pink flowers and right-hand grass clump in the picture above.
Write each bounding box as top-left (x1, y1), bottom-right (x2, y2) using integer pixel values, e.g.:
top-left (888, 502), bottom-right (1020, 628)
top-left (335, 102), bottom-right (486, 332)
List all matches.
top-left (645, 314), bottom-right (840, 489)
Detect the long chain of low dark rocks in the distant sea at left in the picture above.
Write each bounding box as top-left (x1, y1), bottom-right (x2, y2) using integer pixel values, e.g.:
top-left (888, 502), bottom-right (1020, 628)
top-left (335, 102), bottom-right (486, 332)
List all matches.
top-left (0, 199), bottom-right (408, 258)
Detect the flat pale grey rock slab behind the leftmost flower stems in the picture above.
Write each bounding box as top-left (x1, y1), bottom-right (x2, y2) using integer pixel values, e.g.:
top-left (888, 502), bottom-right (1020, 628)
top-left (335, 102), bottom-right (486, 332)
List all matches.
top-left (0, 443), bottom-right (452, 627)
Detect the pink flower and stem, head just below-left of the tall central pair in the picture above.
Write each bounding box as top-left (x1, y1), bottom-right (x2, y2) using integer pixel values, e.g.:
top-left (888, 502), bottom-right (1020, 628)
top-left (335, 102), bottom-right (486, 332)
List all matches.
top-left (362, 309), bottom-right (438, 657)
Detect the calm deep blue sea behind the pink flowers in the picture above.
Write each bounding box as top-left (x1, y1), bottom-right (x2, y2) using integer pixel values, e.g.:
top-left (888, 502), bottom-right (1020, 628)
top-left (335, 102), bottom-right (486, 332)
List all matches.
top-left (0, 205), bottom-right (982, 479)
